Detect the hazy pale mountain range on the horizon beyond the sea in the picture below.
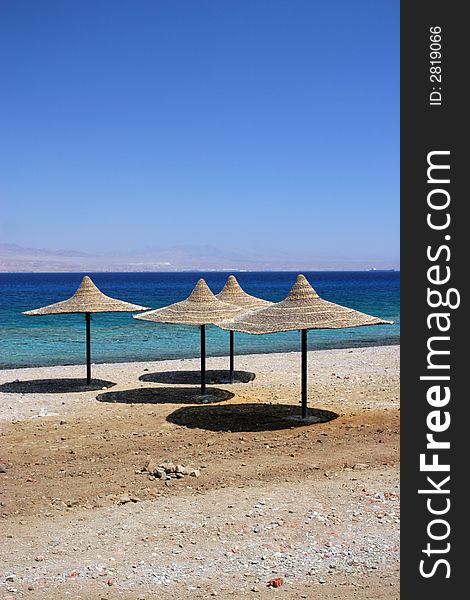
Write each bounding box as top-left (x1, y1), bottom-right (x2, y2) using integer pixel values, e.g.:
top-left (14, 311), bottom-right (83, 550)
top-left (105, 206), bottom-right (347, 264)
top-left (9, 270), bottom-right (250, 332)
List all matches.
top-left (0, 243), bottom-right (397, 273)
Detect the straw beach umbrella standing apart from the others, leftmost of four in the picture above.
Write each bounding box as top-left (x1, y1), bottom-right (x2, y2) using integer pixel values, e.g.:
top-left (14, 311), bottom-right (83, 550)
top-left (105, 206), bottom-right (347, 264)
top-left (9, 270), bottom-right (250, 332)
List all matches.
top-left (23, 275), bottom-right (148, 385)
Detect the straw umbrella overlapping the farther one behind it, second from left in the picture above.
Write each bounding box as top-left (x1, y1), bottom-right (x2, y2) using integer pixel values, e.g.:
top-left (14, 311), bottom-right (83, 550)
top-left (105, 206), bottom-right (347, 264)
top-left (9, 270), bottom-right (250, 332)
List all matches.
top-left (134, 279), bottom-right (243, 395)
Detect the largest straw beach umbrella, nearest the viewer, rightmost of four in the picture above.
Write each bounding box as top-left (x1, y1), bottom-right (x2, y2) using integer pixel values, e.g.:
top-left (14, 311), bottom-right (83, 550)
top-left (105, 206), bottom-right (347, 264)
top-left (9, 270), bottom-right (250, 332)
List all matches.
top-left (219, 275), bottom-right (392, 419)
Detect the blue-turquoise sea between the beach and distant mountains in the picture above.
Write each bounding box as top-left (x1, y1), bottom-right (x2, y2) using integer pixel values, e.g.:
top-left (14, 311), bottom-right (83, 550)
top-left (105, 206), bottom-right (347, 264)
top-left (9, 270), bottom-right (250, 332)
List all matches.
top-left (0, 271), bottom-right (400, 368)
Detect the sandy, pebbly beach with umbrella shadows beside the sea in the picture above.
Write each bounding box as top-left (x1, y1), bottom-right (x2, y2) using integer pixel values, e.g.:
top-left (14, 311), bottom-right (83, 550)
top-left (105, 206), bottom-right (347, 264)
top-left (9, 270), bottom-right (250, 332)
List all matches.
top-left (0, 346), bottom-right (400, 600)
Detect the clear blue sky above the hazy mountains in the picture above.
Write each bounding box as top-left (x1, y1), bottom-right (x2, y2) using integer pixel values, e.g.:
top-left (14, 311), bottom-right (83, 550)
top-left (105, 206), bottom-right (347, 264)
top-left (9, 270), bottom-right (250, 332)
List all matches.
top-left (0, 0), bottom-right (399, 264)
